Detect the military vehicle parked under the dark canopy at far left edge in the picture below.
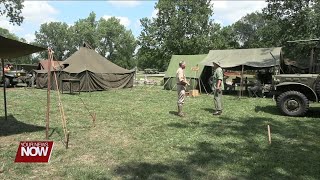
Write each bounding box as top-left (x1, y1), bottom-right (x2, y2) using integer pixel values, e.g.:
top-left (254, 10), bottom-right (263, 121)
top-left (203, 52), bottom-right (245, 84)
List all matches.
top-left (0, 70), bottom-right (28, 87)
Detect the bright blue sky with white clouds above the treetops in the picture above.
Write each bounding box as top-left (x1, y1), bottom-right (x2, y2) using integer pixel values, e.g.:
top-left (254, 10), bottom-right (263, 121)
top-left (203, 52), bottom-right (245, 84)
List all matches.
top-left (0, 0), bottom-right (266, 42)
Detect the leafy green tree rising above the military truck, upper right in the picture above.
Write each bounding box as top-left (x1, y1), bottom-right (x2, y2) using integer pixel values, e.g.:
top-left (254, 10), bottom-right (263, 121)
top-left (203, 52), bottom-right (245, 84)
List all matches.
top-left (263, 0), bottom-right (319, 67)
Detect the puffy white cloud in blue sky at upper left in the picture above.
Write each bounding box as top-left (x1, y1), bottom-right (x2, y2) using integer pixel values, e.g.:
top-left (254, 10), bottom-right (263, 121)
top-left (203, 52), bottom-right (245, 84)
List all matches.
top-left (22, 1), bottom-right (58, 24)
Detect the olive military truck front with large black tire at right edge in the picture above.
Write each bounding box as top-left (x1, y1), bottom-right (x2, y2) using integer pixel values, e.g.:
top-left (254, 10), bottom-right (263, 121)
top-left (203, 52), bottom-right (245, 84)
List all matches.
top-left (272, 40), bottom-right (320, 116)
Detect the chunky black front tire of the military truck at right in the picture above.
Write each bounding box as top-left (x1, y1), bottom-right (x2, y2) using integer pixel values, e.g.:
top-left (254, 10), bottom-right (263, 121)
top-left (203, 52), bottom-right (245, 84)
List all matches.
top-left (277, 91), bottom-right (309, 116)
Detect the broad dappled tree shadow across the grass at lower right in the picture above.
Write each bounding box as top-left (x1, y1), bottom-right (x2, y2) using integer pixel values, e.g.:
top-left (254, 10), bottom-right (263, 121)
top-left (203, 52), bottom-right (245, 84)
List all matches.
top-left (115, 116), bottom-right (320, 179)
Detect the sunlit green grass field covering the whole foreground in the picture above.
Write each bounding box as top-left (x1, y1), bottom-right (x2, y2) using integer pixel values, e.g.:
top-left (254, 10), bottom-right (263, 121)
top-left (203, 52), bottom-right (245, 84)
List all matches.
top-left (0, 86), bottom-right (320, 179)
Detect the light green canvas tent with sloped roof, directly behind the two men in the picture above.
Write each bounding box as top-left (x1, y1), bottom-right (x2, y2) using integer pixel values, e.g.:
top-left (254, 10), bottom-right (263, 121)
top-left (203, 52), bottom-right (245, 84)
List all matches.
top-left (164, 54), bottom-right (211, 91)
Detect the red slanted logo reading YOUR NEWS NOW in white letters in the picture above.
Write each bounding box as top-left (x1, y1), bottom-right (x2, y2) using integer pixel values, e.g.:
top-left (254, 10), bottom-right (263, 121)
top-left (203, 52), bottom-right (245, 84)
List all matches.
top-left (14, 141), bottom-right (53, 163)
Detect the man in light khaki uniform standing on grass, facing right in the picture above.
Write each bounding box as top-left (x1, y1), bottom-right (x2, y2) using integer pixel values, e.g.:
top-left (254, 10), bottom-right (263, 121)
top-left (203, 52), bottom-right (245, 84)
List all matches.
top-left (176, 61), bottom-right (189, 117)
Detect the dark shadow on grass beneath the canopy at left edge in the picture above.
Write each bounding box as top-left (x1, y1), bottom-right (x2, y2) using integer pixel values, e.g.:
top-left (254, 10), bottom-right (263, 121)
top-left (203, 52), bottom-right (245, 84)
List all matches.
top-left (0, 115), bottom-right (46, 137)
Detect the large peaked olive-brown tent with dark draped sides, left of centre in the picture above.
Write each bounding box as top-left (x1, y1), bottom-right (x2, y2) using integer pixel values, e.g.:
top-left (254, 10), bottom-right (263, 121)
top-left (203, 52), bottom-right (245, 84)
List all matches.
top-left (36, 47), bottom-right (134, 91)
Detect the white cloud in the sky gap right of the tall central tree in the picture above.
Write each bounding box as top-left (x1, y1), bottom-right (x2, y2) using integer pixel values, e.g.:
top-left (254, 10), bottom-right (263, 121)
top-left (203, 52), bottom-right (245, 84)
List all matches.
top-left (213, 1), bottom-right (267, 25)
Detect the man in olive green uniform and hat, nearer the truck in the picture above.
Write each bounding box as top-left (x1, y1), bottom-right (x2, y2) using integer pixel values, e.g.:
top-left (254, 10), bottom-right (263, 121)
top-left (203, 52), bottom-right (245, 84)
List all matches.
top-left (212, 63), bottom-right (224, 115)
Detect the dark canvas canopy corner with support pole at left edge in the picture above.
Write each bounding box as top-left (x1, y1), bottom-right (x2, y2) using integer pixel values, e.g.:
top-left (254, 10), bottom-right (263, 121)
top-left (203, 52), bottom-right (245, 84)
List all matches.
top-left (0, 35), bottom-right (46, 119)
